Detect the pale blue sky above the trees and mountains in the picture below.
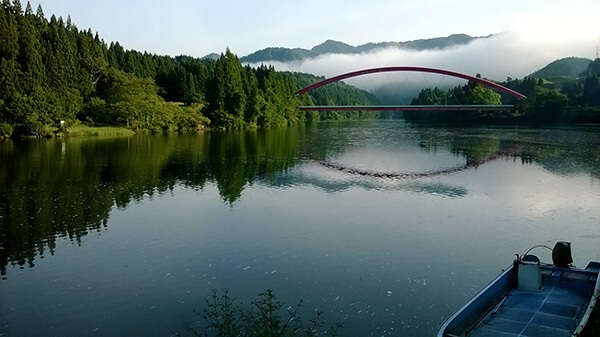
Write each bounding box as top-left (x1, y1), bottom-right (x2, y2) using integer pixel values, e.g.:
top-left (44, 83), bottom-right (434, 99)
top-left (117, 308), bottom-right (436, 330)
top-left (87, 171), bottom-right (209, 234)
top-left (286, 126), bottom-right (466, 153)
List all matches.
top-left (30, 0), bottom-right (600, 57)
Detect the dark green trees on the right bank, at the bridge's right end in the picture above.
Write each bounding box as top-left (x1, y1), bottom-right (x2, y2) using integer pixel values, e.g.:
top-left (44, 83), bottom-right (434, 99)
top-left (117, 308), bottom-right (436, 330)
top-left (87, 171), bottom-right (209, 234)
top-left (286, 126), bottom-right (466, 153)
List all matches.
top-left (404, 59), bottom-right (600, 123)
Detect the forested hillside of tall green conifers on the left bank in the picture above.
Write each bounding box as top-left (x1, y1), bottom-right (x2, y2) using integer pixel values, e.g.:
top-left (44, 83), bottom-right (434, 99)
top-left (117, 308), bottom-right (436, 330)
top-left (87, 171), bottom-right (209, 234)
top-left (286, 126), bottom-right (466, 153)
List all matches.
top-left (0, 0), bottom-right (376, 137)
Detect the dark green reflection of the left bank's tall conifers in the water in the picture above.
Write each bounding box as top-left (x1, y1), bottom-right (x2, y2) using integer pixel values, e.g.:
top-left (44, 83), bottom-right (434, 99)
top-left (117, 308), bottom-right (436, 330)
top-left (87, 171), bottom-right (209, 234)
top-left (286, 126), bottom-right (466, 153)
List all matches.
top-left (0, 128), bottom-right (301, 275)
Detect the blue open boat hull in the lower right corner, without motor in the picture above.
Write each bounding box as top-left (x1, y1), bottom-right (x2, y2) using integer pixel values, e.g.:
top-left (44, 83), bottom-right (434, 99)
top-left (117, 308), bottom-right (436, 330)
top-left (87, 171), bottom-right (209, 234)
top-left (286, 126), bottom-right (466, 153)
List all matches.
top-left (438, 262), bottom-right (600, 337)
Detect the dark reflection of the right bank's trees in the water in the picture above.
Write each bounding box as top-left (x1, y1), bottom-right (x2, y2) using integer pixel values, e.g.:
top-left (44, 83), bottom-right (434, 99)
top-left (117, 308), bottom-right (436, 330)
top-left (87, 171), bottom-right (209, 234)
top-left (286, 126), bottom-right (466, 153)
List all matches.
top-left (410, 123), bottom-right (600, 178)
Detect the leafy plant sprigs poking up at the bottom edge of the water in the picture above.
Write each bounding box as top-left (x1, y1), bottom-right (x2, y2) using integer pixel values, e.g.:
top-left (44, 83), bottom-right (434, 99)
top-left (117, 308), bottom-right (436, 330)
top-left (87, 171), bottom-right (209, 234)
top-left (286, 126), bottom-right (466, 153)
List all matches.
top-left (186, 289), bottom-right (343, 337)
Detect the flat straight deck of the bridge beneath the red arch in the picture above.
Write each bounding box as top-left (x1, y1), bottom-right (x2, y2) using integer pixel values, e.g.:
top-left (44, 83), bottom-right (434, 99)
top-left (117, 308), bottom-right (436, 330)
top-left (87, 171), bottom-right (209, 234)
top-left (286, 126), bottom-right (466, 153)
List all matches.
top-left (300, 104), bottom-right (515, 111)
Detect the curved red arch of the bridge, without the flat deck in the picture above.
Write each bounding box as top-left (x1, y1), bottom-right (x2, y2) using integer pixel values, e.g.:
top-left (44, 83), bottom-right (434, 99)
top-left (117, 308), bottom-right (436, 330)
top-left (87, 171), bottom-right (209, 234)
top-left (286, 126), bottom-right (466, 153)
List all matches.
top-left (296, 66), bottom-right (527, 98)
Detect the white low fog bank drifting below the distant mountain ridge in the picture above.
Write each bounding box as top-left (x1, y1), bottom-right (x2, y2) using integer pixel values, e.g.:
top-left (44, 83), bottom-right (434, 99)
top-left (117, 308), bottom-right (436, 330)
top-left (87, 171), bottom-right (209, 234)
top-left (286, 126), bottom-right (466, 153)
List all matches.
top-left (246, 32), bottom-right (600, 91)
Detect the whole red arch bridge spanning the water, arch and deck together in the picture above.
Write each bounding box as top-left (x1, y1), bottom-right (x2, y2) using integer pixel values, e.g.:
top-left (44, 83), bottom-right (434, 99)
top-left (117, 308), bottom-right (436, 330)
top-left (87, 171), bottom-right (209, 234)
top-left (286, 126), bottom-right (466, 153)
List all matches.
top-left (296, 66), bottom-right (527, 111)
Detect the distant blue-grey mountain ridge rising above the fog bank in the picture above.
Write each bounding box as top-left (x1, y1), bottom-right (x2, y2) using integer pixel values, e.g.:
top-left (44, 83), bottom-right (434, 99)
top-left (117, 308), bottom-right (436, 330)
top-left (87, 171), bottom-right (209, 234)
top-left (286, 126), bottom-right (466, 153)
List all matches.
top-left (240, 34), bottom-right (482, 63)
